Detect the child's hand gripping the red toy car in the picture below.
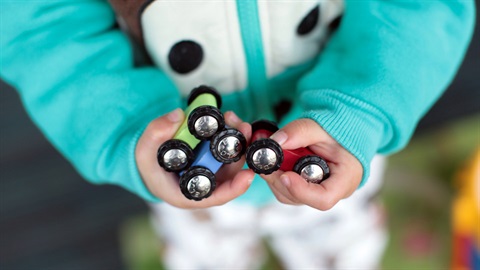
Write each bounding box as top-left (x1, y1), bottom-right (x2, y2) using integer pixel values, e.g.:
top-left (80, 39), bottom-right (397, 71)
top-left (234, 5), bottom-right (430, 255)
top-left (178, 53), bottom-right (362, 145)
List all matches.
top-left (261, 119), bottom-right (363, 210)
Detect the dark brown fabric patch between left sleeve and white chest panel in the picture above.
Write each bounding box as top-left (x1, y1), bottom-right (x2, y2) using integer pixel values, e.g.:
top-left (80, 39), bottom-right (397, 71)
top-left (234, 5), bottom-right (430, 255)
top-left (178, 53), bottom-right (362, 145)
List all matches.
top-left (109, 0), bottom-right (155, 45)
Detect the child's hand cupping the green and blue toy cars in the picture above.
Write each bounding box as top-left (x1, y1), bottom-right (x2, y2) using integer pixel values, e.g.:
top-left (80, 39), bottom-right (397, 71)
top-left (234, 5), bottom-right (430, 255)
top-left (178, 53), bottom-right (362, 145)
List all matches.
top-left (135, 109), bottom-right (254, 208)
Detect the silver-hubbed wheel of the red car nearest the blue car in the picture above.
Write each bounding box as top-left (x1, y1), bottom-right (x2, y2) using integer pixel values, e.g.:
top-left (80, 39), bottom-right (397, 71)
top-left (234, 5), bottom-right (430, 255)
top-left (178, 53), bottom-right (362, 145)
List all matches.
top-left (246, 139), bottom-right (283, 174)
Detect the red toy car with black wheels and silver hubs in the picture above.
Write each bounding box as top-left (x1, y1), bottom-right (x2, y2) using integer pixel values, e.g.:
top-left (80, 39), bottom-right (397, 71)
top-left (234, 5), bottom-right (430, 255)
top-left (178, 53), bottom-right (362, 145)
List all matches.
top-left (246, 120), bottom-right (330, 183)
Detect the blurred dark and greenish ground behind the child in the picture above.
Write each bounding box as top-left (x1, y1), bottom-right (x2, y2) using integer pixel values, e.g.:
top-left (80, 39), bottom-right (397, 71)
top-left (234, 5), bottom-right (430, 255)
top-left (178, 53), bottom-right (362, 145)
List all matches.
top-left (0, 13), bottom-right (480, 269)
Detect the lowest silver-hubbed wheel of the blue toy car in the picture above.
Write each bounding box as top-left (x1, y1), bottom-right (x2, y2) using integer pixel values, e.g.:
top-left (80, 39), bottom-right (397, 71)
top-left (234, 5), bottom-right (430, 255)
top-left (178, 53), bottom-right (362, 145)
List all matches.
top-left (180, 166), bottom-right (216, 201)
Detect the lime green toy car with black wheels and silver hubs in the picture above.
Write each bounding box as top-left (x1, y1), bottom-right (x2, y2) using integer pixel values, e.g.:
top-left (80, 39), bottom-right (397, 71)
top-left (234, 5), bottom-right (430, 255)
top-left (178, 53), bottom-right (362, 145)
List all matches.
top-left (157, 85), bottom-right (225, 172)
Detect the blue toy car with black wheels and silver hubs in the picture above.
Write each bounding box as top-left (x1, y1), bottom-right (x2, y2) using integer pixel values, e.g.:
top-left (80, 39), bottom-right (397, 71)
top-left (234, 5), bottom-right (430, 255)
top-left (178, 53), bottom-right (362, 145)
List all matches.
top-left (179, 128), bottom-right (246, 201)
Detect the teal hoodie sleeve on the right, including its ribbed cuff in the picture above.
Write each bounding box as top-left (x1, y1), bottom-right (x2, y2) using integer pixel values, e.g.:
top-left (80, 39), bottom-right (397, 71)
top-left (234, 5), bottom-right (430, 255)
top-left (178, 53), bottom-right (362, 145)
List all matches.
top-left (299, 0), bottom-right (475, 185)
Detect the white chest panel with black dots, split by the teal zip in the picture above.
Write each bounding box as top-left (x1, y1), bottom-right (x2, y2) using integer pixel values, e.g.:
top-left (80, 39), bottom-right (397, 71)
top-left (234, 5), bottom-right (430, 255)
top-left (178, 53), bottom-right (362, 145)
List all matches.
top-left (141, 0), bottom-right (343, 96)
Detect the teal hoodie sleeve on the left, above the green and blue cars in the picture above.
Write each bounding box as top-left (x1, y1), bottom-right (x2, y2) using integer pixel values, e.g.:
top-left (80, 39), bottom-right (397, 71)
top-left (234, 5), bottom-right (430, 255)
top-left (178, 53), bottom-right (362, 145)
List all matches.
top-left (0, 0), bottom-right (180, 201)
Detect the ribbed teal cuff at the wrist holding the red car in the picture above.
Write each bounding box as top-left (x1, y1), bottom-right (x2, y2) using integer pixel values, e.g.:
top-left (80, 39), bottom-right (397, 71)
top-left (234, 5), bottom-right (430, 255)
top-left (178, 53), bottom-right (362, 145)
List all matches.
top-left (300, 89), bottom-right (393, 187)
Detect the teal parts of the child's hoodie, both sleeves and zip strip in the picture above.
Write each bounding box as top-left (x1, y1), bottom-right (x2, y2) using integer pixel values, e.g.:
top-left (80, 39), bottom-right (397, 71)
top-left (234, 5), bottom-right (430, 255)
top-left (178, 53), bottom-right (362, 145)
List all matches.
top-left (0, 0), bottom-right (475, 201)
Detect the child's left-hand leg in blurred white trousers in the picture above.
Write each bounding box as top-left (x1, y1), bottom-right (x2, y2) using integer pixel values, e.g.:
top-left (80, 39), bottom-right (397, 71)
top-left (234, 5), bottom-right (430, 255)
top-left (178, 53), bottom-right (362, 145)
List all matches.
top-left (151, 203), bottom-right (265, 269)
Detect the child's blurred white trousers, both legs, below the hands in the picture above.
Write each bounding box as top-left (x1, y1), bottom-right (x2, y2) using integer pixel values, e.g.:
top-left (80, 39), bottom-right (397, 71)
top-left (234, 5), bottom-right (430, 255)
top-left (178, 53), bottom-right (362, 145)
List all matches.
top-left (151, 156), bottom-right (387, 269)
